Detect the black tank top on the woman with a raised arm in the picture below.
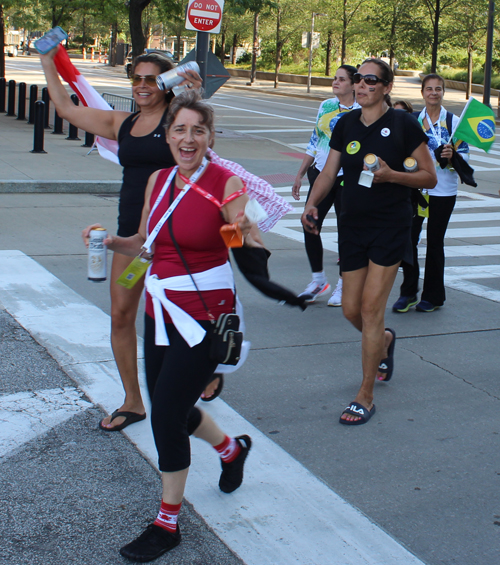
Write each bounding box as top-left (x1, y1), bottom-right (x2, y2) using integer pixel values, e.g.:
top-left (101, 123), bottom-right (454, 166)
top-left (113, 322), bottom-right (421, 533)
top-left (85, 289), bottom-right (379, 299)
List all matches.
top-left (118, 111), bottom-right (175, 237)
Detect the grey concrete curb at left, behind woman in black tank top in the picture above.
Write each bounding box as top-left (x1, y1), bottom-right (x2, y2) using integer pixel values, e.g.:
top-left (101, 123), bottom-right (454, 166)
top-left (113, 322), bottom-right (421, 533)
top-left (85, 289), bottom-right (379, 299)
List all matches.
top-left (0, 180), bottom-right (122, 194)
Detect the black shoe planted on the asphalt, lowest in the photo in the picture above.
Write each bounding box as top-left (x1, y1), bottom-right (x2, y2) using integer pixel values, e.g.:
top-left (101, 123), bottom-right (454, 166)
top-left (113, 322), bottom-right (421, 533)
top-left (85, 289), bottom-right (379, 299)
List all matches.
top-left (120, 524), bottom-right (181, 563)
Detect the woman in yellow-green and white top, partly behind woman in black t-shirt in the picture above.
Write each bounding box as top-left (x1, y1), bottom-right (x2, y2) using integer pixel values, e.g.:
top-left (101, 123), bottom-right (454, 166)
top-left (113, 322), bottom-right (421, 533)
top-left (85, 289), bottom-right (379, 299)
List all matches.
top-left (292, 65), bottom-right (359, 306)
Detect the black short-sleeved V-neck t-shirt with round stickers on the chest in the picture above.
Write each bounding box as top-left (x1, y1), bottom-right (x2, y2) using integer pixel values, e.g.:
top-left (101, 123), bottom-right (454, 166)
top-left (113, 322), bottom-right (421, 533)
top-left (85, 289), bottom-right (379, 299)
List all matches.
top-left (330, 108), bottom-right (428, 227)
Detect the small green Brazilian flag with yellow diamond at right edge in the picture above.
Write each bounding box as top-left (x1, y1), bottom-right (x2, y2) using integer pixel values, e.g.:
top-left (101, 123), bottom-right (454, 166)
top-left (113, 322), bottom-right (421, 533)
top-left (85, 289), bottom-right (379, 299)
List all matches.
top-left (453, 98), bottom-right (495, 151)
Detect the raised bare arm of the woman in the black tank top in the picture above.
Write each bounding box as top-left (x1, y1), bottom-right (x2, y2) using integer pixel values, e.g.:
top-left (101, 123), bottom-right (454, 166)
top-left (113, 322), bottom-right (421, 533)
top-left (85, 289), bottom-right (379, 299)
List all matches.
top-left (40, 47), bottom-right (130, 140)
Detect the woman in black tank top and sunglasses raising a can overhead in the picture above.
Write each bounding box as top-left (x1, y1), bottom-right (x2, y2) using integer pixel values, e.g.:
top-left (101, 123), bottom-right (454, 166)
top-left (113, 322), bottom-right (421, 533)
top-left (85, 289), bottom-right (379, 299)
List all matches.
top-left (40, 49), bottom-right (201, 431)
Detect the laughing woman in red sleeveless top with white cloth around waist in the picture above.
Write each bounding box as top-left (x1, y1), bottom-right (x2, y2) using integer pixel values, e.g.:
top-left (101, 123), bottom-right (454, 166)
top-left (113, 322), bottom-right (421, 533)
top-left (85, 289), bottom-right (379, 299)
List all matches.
top-left (98, 90), bottom-right (253, 561)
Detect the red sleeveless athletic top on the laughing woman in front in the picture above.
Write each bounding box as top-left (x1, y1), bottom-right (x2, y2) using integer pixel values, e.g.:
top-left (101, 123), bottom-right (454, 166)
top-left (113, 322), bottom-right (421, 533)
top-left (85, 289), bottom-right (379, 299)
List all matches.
top-left (146, 163), bottom-right (235, 323)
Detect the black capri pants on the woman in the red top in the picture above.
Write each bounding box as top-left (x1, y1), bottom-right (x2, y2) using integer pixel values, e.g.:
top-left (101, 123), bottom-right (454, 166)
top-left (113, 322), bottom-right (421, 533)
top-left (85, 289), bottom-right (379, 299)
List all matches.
top-left (144, 314), bottom-right (217, 473)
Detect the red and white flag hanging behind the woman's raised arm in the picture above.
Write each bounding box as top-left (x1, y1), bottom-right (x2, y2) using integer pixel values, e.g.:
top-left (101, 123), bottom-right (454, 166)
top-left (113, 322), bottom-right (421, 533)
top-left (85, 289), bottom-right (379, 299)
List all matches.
top-left (54, 45), bottom-right (120, 165)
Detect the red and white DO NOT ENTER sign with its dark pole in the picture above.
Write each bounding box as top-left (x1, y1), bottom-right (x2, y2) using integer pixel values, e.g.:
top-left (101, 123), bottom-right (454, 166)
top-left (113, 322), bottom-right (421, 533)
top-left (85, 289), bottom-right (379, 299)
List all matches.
top-left (185, 0), bottom-right (224, 97)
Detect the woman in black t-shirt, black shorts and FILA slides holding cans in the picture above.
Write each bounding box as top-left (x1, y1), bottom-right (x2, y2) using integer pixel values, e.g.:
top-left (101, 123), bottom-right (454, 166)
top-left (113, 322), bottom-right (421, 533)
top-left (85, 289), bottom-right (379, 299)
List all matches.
top-left (302, 59), bottom-right (436, 425)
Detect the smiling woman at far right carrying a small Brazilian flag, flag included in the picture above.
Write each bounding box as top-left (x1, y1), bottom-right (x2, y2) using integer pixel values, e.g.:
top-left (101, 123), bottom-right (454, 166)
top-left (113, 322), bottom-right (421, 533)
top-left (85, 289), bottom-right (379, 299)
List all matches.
top-left (392, 74), bottom-right (495, 313)
